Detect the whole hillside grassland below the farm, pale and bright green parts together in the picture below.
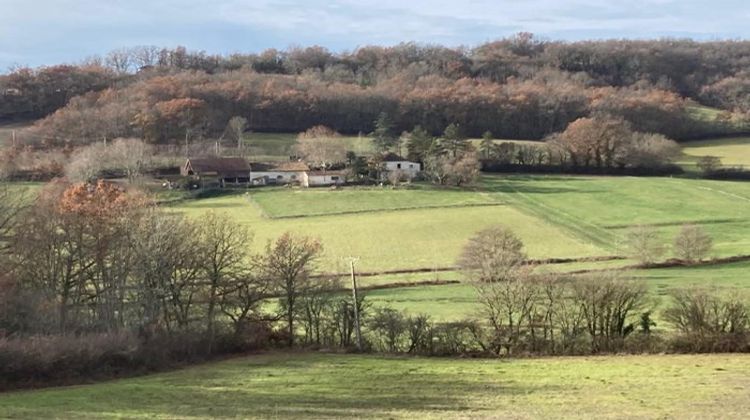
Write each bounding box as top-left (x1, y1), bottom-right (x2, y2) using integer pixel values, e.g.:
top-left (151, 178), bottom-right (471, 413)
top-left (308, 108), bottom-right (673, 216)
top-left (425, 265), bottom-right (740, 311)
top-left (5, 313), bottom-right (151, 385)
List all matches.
top-left (174, 175), bottom-right (750, 271)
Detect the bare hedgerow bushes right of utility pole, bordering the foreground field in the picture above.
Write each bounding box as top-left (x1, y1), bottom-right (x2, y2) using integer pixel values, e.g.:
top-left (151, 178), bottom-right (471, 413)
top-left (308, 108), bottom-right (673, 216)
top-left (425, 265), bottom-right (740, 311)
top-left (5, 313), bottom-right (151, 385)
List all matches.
top-left (365, 284), bottom-right (750, 357)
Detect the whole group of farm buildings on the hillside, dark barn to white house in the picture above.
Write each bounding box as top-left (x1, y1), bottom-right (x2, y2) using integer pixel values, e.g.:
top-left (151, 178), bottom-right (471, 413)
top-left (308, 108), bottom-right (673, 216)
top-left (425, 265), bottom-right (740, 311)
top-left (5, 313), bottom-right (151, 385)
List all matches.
top-left (180, 153), bottom-right (421, 188)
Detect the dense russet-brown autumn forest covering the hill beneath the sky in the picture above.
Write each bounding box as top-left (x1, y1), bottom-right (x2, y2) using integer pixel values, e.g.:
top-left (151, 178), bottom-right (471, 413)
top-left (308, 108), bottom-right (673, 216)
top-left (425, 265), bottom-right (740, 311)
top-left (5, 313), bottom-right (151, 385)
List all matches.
top-left (0, 33), bottom-right (750, 146)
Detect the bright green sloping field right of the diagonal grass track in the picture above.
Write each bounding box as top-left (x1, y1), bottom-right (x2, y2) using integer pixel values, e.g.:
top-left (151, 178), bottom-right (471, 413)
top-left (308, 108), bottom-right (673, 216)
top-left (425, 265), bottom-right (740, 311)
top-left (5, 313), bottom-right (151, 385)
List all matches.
top-left (483, 175), bottom-right (750, 256)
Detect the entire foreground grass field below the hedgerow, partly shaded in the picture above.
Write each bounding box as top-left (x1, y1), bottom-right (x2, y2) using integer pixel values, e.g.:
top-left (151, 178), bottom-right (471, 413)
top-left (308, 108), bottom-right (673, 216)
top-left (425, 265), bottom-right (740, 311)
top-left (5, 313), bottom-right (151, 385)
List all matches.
top-left (0, 354), bottom-right (750, 419)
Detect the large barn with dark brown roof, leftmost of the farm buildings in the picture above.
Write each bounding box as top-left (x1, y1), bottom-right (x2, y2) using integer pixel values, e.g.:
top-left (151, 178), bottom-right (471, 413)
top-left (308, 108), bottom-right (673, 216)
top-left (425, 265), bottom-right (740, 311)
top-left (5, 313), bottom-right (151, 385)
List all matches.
top-left (180, 156), bottom-right (250, 187)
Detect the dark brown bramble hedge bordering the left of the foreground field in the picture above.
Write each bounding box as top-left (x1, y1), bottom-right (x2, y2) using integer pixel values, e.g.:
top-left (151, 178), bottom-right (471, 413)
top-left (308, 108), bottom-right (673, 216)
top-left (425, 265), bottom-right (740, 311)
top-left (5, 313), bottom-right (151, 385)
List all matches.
top-left (0, 324), bottom-right (273, 390)
